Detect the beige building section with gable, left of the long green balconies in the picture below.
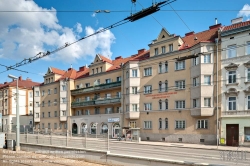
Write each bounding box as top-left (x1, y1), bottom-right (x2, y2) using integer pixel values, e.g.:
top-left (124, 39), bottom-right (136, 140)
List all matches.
top-left (34, 67), bottom-right (77, 132)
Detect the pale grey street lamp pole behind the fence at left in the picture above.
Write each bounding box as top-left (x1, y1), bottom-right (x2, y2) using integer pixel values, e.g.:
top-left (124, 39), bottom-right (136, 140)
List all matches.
top-left (8, 74), bottom-right (20, 151)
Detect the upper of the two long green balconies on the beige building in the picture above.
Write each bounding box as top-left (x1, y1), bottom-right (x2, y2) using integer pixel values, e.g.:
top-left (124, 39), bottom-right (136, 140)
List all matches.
top-left (71, 81), bottom-right (121, 95)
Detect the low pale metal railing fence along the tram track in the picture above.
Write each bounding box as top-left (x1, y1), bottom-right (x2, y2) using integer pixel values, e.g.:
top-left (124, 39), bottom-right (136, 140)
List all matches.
top-left (7, 131), bottom-right (109, 151)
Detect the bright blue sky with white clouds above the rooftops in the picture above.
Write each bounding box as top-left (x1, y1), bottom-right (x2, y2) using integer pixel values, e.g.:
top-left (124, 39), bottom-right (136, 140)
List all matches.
top-left (0, 0), bottom-right (250, 83)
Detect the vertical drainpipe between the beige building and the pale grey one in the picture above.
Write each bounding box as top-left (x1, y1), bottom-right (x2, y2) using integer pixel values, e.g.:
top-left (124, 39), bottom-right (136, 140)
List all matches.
top-left (215, 38), bottom-right (219, 149)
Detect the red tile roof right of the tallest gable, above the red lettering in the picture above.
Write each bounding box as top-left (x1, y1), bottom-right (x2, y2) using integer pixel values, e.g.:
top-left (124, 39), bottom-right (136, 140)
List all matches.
top-left (179, 24), bottom-right (221, 50)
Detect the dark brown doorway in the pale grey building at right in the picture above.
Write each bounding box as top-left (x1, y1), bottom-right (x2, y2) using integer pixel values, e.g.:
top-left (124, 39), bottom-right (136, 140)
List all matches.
top-left (226, 124), bottom-right (239, 146)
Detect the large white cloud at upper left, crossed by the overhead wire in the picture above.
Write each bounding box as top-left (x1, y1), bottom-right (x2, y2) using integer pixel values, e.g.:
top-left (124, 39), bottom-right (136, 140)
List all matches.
top-left (0, 0), bottom-right (115, 63)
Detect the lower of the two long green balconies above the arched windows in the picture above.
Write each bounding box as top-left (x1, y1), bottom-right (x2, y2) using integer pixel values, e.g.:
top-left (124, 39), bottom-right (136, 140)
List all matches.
top-left (71, 97), bottom-right (121, 108)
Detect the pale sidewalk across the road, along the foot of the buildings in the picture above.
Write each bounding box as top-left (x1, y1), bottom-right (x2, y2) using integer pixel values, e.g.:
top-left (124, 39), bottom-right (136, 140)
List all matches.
top-left (111, 140), bottom-right (250, 153)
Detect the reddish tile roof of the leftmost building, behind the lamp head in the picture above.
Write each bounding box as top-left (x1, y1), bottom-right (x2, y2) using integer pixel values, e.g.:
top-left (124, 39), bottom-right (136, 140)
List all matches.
top-left (0, 77), bottom-right (40, 89)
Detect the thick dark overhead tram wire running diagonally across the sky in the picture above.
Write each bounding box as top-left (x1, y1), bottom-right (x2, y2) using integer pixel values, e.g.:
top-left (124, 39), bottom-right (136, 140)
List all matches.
top-left (1, 0), bottom-right (176, 73)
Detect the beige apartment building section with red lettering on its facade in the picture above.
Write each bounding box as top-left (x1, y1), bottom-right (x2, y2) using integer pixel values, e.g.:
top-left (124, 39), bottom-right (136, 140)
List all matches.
top-left (124, 24), bottom-right (221, 144)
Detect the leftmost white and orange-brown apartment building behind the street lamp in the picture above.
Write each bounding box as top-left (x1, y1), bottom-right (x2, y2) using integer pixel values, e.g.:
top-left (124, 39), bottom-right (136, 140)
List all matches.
top-left (0, 77), bottom-right (39, 132)
